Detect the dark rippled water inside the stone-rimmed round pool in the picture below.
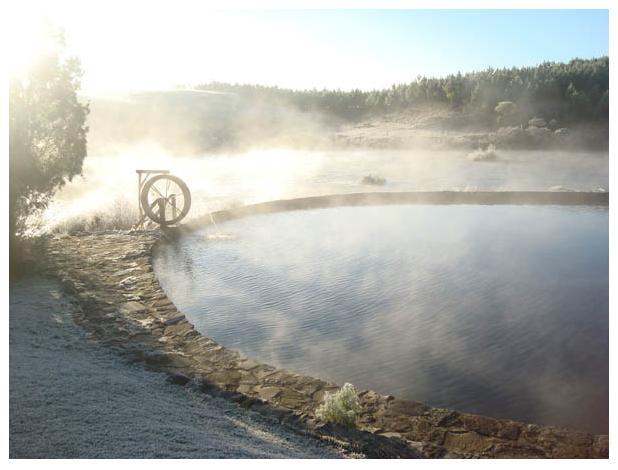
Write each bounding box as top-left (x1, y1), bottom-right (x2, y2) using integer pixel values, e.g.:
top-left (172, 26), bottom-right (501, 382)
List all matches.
top-left (155, 206), bottom-right (608, 433)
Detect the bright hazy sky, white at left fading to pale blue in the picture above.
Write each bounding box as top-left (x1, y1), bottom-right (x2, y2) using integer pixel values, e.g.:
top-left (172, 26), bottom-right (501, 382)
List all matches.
top-left (4, 0), bottom-right (609, 92)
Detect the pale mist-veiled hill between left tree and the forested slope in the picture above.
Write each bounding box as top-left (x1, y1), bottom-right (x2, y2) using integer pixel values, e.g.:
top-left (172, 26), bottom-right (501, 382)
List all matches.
top-left (83, 90), bottom-right (336, 154)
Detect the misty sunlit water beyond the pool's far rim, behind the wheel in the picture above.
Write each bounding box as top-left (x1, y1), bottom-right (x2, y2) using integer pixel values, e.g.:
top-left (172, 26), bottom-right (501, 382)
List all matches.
top-left (47, 147), bottom-right (609, 230)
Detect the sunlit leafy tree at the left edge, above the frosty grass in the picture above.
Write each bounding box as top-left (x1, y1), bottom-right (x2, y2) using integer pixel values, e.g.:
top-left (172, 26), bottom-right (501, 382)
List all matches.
top-left (9, 27), bottom-right (88, 257)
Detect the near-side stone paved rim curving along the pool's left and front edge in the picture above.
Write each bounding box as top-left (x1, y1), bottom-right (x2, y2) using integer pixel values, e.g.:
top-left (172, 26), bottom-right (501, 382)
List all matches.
top-left (47, 232), bottom-right (609, 458)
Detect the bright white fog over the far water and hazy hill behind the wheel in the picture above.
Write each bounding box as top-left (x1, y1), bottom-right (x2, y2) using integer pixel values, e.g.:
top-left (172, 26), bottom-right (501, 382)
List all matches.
top-left (39, 90), bottom-right (609, 231)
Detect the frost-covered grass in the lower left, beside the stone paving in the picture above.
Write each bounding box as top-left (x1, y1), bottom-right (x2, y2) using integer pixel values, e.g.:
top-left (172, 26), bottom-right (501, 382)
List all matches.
top-left (9, 278), bottom-right (340, 458)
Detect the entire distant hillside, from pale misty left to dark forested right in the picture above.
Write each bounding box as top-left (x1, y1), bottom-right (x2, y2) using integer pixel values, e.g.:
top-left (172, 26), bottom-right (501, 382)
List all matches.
top-left (85, 57), bottom-right (609, 154)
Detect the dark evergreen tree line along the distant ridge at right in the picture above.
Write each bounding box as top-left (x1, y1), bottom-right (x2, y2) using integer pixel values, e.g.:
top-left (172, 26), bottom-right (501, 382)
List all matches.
top-left (197, 56), bottom-right (609, 124)
